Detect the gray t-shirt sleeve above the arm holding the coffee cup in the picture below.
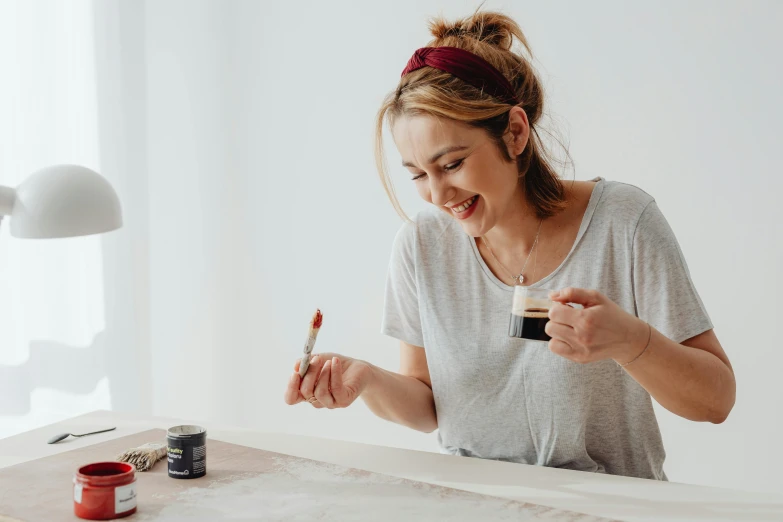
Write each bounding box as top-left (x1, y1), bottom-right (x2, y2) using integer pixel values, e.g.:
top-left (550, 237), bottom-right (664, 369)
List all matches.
top-left (633, 201), bottom-right (712, 343)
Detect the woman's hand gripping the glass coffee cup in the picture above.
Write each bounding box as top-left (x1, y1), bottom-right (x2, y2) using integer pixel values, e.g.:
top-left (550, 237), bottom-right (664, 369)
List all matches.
top-left (546, 288), bottom-right (648, 363)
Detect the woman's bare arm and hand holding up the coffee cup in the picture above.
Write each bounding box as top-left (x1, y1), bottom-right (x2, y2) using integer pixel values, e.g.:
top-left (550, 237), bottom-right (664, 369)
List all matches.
top-left (546, 288), bottom-right (736, 424)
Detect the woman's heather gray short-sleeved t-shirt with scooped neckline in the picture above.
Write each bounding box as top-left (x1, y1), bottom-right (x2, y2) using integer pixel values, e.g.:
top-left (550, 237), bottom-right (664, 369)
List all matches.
top-left (382, 178), bottom-right (712, 480)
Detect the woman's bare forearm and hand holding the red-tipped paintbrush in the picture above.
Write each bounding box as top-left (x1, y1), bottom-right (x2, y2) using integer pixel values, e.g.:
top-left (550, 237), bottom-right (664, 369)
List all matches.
top-left (285, 342), bottom-right (438, 433)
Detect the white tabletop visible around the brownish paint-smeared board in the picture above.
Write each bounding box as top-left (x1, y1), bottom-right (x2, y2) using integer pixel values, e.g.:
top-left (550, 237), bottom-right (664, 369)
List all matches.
top-left (0, 411), bottom-right (783, 521)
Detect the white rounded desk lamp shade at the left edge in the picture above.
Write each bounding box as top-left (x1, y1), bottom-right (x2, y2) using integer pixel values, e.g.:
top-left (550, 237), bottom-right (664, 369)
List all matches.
top-left (0, 165), bottom-right (122, 239)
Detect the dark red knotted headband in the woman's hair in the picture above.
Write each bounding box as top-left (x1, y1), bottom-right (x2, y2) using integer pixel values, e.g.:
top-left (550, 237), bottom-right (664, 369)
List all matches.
top-left (400, 47), bottom-right (519, 105)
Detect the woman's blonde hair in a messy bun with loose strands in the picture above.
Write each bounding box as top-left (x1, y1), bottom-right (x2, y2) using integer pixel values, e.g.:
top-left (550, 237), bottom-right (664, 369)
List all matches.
top-left (375, 11), bottom-right (570, 220)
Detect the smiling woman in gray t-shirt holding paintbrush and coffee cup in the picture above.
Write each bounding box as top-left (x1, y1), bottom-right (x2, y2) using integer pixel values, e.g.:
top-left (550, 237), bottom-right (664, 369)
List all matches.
top-left (286, 12), bottom-right (735, 480)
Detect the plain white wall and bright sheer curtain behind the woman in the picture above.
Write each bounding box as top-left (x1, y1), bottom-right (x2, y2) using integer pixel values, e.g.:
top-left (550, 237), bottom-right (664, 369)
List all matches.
top-left (0, 0), bottom-right (783, 491)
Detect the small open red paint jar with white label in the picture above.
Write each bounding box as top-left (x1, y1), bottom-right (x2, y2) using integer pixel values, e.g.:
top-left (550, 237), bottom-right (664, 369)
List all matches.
top-left (73, 462), bottom-right (136, 520)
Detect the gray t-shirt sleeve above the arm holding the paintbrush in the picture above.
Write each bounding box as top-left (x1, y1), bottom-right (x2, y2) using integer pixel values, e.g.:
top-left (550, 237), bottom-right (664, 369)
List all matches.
top-left (381, 219), bottom-right (424, 346)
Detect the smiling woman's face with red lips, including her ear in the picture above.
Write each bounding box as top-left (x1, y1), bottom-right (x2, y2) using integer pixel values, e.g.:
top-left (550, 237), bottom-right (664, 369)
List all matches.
top-left (392, 109), bottom-right (527, 237)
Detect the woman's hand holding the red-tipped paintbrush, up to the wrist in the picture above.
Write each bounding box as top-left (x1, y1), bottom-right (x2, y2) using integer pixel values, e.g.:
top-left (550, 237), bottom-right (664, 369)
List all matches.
top-left (285, 353), bottom-right (372, 410)
